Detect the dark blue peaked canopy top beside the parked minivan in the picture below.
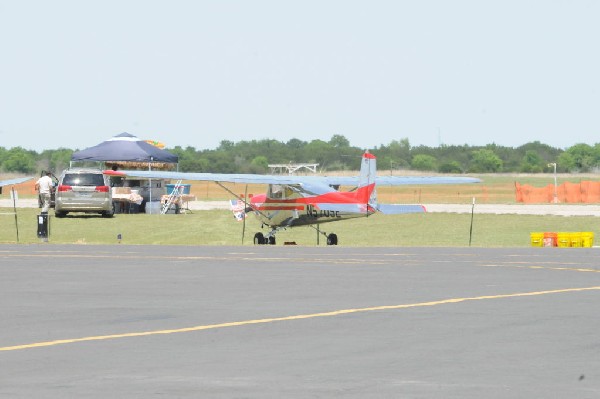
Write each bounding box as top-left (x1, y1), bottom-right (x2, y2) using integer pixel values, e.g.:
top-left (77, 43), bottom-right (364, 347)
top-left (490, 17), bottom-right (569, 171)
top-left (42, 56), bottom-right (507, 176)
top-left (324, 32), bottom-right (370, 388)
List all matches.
top-left (71, 133), bottom-right (178, 163)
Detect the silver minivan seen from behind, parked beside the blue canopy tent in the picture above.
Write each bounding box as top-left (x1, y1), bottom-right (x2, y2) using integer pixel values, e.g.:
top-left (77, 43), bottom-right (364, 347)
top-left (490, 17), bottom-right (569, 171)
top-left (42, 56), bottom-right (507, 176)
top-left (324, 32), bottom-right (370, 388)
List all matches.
top-left (54, 168), bottom-right (114, 217)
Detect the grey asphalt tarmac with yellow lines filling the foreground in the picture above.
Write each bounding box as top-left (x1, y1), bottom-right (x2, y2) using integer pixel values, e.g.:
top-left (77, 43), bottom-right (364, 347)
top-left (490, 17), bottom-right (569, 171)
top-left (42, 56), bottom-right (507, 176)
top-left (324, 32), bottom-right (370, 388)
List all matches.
top-left (0, 244), bottom-right (600, 398)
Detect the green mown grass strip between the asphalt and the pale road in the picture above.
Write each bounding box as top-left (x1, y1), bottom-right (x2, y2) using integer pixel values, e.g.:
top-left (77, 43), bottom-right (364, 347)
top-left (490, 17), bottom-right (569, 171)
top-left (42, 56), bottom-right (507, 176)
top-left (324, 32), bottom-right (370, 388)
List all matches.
top-left (0, 208), bottom-right (600, 247)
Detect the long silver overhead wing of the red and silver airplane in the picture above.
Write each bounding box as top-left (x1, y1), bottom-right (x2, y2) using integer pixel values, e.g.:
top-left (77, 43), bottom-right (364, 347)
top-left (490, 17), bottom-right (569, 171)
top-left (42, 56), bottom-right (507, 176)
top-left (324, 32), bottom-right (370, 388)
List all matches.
top-left (104, 170), bottom-right (481, 186)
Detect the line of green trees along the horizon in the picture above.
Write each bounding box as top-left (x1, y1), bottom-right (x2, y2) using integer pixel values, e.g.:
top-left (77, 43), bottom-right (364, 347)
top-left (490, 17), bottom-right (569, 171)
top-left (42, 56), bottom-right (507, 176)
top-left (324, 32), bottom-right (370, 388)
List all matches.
top-left (0, 135), bottom-right (600, 174)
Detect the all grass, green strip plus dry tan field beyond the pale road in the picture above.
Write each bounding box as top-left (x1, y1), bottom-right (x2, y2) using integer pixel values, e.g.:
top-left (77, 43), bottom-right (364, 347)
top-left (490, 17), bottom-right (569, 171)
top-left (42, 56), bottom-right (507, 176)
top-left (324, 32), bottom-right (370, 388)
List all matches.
top-left (0, 172), bottom-right (600, 247)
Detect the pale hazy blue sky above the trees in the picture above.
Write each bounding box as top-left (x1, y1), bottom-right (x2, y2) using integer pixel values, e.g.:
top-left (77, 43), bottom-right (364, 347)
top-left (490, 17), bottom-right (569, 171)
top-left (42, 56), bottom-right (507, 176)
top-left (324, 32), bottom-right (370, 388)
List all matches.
top-left (0, 0), bottom-right (600, 151)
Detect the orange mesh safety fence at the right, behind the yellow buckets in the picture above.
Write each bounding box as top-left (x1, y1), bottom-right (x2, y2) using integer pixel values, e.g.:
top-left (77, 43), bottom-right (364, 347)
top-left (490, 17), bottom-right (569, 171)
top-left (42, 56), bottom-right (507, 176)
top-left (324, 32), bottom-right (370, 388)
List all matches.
top-left (515, 181), bottom-right (600, 204)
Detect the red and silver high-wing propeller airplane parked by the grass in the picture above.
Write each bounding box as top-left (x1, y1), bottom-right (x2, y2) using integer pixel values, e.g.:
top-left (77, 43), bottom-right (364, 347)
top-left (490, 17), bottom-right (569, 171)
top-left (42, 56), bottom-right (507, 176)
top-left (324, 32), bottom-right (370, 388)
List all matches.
top-left (104, 152), bottom-right (480, 245)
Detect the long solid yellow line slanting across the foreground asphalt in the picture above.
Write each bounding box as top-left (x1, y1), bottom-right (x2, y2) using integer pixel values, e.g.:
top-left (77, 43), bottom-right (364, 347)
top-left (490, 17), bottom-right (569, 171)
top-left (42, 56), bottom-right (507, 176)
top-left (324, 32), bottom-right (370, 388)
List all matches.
top-left (0, 286), bottom-right (600, 352)
